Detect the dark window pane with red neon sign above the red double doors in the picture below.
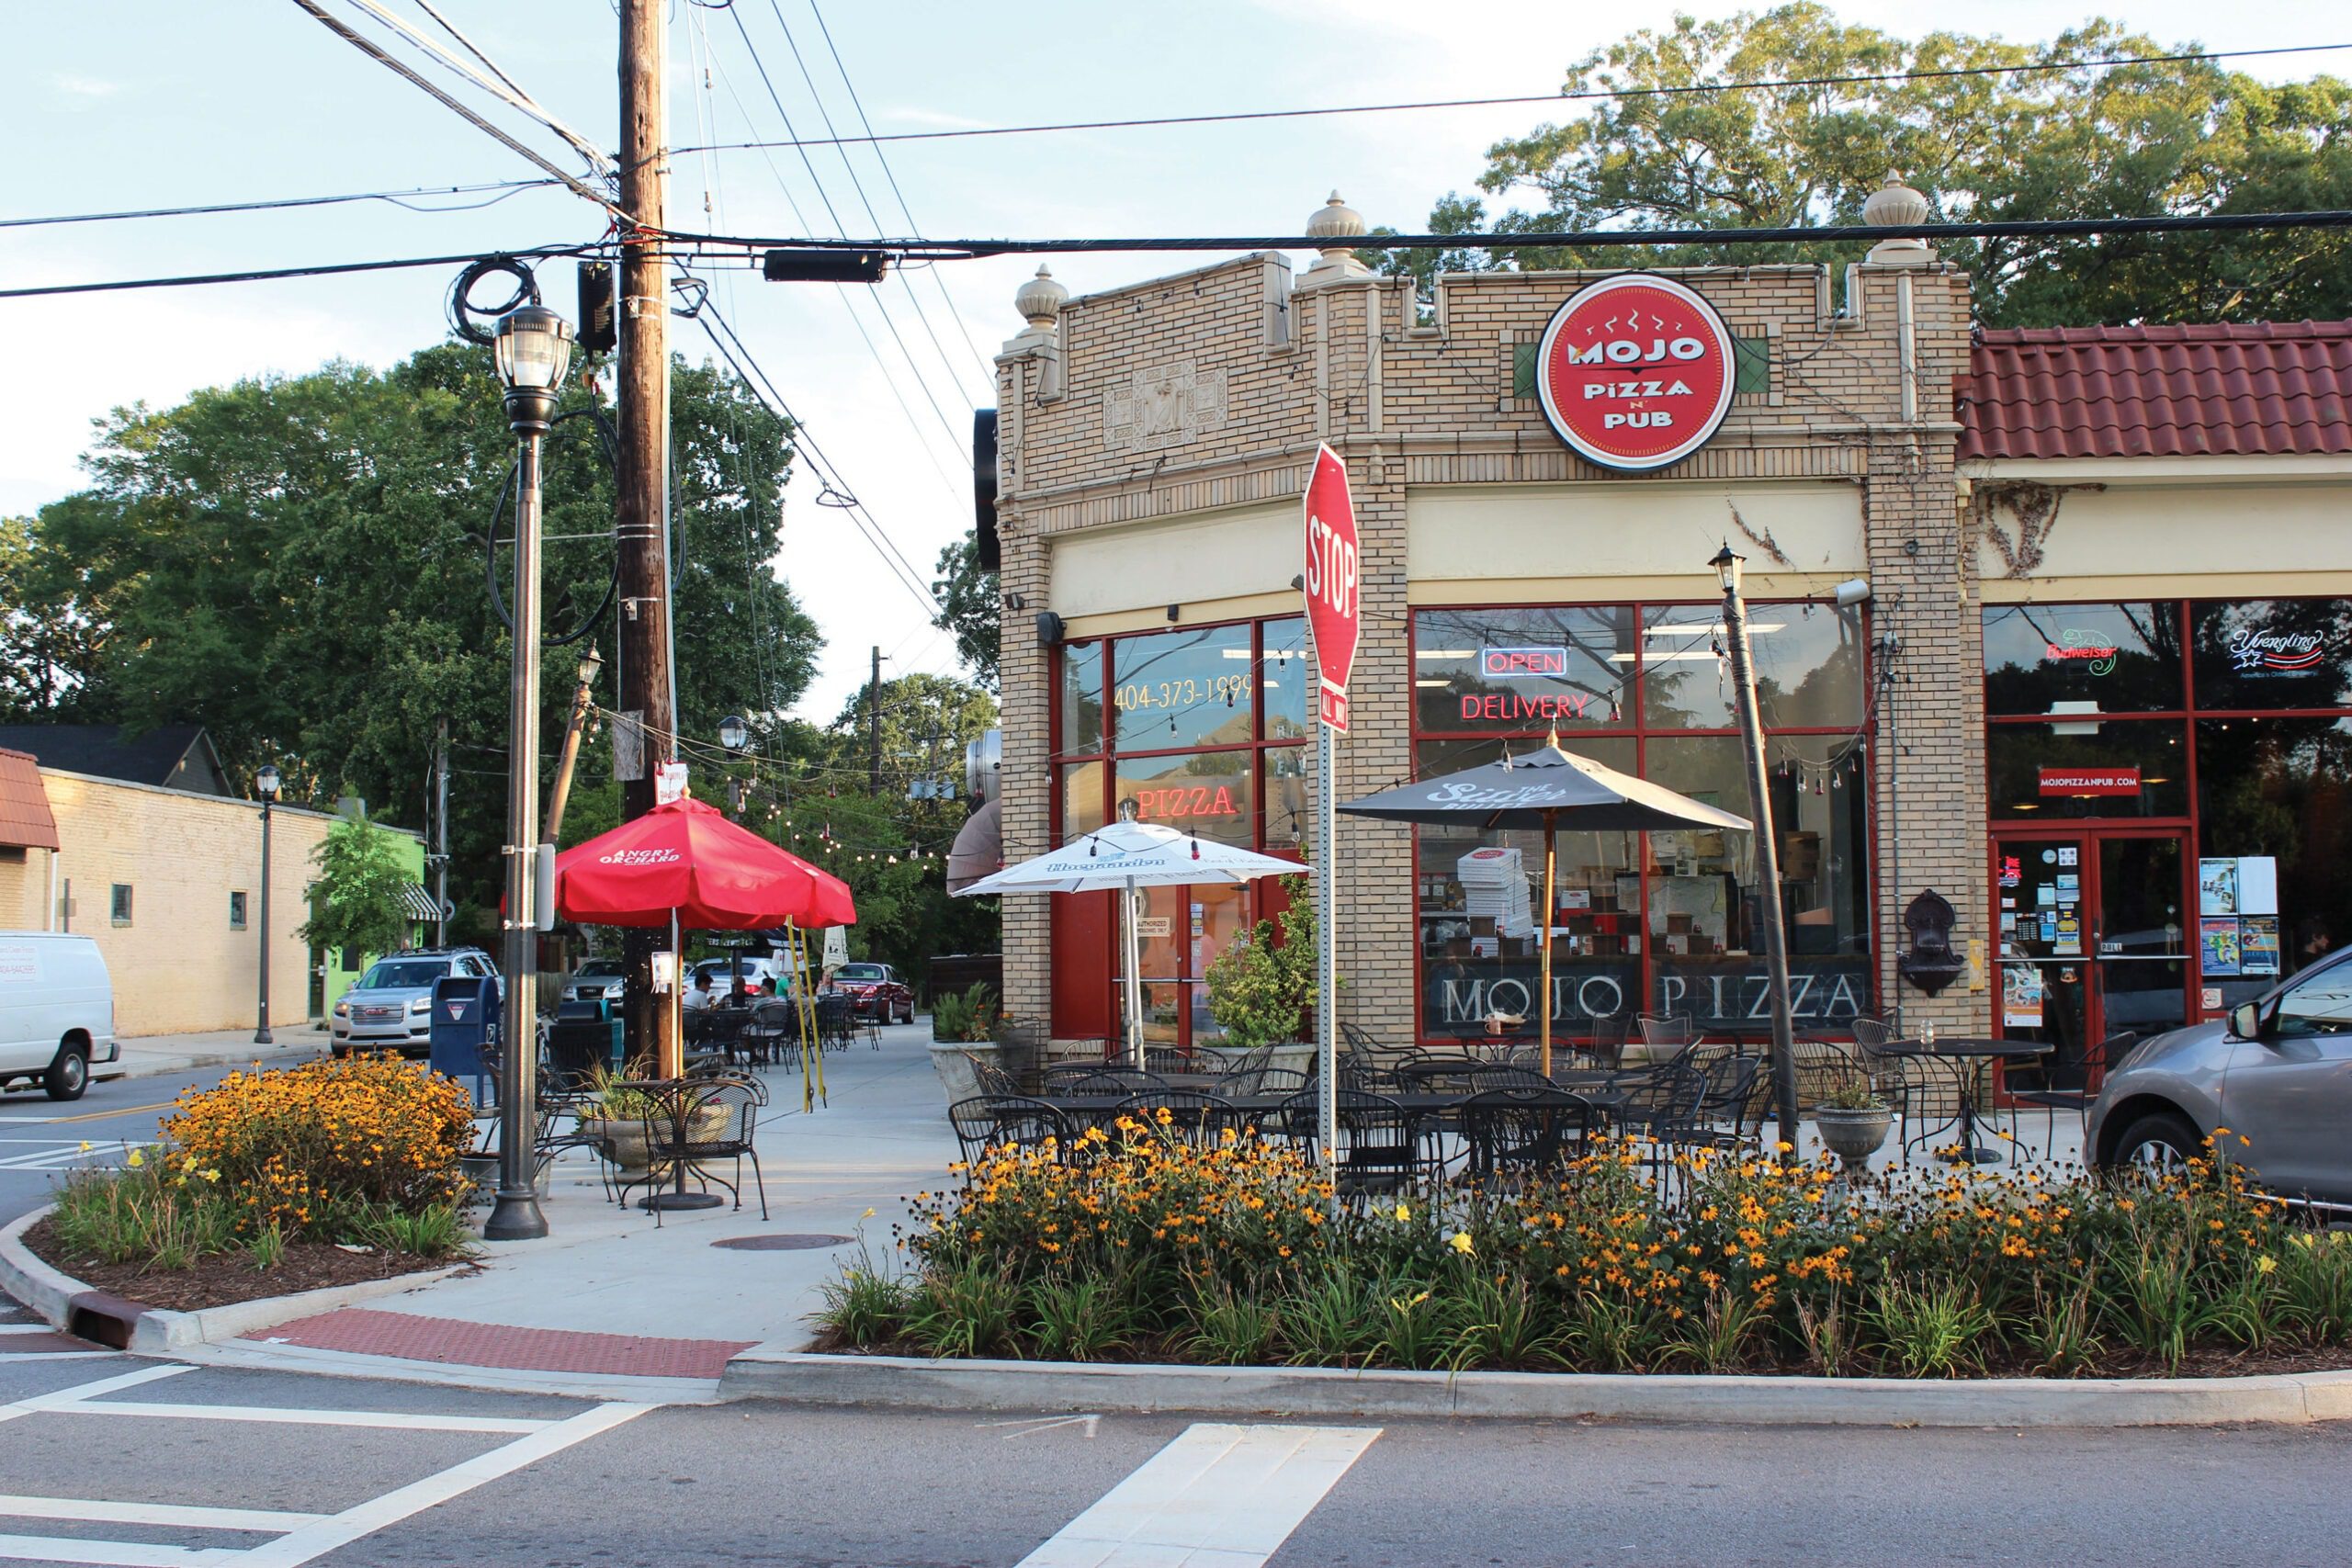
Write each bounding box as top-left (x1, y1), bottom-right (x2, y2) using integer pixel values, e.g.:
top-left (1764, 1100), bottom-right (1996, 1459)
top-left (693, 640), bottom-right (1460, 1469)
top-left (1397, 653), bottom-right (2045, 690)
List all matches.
top-left (1985, 602), bottom-right (2185, 715)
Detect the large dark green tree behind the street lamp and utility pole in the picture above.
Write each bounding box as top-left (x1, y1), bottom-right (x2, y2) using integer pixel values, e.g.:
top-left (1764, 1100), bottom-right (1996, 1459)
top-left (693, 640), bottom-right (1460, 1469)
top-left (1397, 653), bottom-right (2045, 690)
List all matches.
top-left (0, 344), bottom-right (819, 926)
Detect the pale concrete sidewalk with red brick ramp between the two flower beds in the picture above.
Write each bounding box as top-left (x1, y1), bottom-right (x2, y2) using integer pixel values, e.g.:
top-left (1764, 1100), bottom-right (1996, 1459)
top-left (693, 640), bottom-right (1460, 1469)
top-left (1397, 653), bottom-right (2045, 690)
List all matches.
top-left (186, 1021), bottom-right (957, 1399)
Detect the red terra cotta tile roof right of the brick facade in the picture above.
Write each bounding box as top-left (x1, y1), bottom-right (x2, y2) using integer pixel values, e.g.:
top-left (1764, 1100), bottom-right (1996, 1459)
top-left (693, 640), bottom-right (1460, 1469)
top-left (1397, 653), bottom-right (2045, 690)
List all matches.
top-left (1954, 322), bottom-right (2352, 458)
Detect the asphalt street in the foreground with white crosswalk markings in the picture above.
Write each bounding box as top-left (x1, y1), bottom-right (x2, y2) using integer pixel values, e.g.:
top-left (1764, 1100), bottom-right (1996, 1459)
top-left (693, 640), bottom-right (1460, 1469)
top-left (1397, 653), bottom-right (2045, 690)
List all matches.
top-left (0, 1314), bottom-right (2352, 1568)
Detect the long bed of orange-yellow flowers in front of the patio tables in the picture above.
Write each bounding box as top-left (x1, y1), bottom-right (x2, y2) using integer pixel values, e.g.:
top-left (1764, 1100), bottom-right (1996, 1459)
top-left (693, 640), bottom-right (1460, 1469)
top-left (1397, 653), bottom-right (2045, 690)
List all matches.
top-left (820, 1122), bottom-right (2352, 1378)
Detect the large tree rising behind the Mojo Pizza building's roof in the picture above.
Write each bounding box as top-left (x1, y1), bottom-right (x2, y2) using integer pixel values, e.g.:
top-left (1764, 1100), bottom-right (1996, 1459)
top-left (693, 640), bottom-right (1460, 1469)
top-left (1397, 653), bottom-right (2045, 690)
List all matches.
top-left (1366, 3), bottom-right (2352, 327)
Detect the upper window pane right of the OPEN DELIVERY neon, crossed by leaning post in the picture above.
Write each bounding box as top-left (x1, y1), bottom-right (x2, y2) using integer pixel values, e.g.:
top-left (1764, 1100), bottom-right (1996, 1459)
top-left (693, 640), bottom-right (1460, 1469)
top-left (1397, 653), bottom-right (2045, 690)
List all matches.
top-left (1642, 604), bottom-right (1863, 728)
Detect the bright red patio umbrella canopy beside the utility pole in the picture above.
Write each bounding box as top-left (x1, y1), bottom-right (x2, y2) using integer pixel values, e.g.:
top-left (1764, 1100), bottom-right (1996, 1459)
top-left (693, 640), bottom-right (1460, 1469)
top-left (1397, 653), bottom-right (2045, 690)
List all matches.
top-left (555, 797), bottom-right (858, 931)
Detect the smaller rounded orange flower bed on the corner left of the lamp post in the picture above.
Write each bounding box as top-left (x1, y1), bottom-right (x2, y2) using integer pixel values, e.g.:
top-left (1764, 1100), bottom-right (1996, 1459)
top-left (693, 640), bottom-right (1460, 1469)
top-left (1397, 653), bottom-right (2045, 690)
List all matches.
top-left (26, 1058), bottom-right (473, 1307)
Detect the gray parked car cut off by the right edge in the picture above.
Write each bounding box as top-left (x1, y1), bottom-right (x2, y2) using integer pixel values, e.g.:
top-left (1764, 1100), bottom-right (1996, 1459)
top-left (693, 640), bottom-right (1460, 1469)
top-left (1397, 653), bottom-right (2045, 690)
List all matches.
top-left (2086, 950), bottom-right (2352, 1206)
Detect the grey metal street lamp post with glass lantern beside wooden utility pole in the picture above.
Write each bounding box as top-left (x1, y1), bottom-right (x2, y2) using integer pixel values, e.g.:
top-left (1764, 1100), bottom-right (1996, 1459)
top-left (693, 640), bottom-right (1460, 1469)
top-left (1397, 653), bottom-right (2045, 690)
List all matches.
top-left (482, 306), bottom-right (571, 1241)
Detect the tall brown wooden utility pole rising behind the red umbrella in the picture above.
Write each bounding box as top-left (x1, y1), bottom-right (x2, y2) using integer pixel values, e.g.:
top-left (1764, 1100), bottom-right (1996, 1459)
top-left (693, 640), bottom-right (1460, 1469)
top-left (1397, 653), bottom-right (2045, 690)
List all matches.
top-left (614, 0), bottom-right (677, 1063)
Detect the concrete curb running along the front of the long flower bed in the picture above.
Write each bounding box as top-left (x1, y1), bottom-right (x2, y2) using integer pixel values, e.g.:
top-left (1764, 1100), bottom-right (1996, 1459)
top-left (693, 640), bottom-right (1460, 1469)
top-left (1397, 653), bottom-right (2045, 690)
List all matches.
top-left (719, 1345), bottom-right (2352, 1427)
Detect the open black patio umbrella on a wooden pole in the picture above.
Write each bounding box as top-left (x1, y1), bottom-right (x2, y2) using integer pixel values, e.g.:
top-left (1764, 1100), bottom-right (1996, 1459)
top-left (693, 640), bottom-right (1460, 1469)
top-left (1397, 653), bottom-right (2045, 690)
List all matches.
top-left (1339, 733), bottom-right (1750, 1072)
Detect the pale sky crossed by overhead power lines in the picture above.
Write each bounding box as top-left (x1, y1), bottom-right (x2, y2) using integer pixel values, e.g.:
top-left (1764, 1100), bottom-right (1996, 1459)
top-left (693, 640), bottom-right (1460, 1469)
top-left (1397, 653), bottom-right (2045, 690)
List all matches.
top-left (0, 0), bottom-right (2314, 719)
